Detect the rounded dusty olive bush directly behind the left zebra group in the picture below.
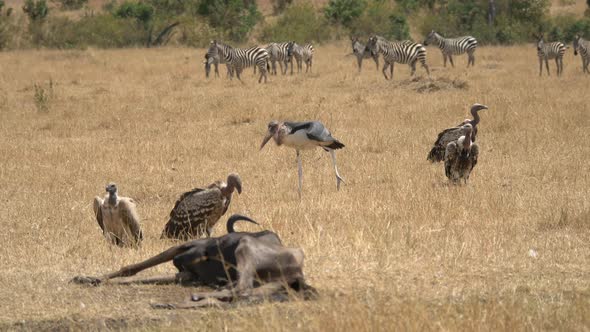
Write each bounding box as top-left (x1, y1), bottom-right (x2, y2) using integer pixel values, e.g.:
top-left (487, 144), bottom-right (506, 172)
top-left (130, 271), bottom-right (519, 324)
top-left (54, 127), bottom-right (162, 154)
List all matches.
top-left (261, 3), bottom-right (331, 43)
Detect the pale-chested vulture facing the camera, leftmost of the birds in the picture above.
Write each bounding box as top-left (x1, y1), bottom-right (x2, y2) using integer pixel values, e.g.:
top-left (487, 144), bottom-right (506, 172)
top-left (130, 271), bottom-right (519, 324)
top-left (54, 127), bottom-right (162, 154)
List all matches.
top-left (94, 183), bottom-right (143, 247)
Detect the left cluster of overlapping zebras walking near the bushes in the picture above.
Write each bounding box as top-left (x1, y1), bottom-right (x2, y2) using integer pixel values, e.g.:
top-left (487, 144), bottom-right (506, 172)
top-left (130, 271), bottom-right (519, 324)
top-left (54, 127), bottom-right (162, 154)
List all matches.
top-left (205, 40), bottom-right (314, 83)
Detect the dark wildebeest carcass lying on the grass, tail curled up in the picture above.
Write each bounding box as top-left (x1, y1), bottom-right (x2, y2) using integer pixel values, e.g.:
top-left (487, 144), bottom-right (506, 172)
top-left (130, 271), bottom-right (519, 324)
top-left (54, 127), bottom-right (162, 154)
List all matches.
top-left (72, 214), bottom-right (316, 308)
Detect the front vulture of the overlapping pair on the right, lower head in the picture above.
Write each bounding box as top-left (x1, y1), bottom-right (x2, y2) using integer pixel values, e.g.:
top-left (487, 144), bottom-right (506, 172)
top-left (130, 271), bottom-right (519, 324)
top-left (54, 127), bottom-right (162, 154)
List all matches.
top-left (445, 123), bottom-right (479, 183)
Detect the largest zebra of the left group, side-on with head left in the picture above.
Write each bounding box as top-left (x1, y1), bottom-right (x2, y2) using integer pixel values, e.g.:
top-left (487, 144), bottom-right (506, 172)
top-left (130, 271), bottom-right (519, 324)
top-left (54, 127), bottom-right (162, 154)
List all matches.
top-left (208, 40), bottom-right (268, 83)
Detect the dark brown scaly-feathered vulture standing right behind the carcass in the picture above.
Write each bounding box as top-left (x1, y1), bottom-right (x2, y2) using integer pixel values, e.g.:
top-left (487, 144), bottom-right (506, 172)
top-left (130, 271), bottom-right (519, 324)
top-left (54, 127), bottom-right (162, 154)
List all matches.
top-left (162, 173), bottom-right (242, 240)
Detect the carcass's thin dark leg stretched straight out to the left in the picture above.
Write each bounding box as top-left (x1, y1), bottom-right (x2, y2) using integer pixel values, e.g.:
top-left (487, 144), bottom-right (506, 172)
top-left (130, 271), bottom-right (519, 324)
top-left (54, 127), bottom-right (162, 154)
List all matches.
top-left (71, 245), bottom-right (191, 285)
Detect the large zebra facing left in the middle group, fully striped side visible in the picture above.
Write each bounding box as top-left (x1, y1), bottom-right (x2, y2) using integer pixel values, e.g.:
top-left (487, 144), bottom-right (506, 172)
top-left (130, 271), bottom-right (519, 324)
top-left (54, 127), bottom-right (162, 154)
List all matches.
top-left (367, 36), bottom-right (430, 79)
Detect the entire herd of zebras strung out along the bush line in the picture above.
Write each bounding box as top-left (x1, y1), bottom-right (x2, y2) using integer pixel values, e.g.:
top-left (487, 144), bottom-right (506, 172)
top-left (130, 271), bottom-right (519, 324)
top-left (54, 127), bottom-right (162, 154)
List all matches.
top-left (205, 30), bottom-right (590, 83)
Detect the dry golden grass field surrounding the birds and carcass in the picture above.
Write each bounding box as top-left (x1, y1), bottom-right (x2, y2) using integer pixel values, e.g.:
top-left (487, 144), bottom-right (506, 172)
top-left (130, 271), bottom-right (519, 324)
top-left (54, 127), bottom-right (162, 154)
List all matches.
top-left (0, 44), bottom-right (590, 331)
